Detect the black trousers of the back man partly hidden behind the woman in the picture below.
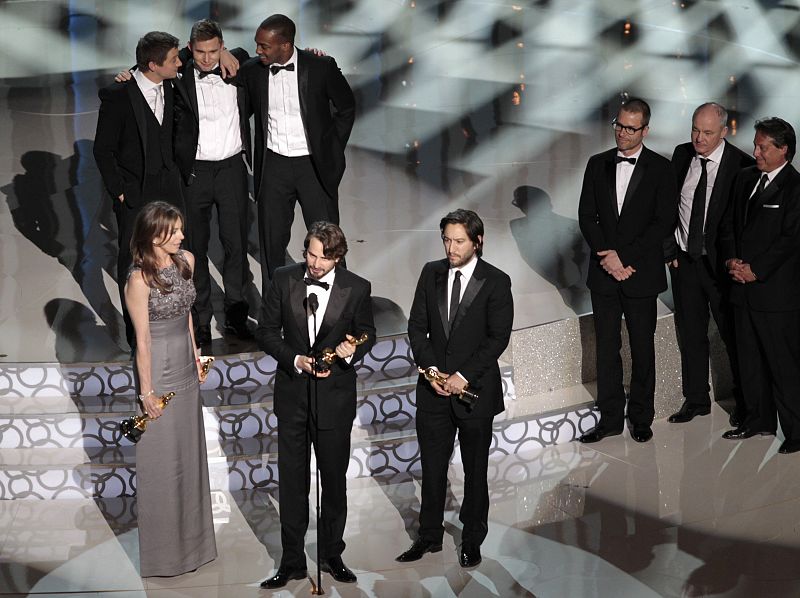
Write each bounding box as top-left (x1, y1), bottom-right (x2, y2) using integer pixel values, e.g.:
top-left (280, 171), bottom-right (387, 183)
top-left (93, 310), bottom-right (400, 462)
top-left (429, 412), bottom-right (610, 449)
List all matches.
top-left (112, 168), bottom-right (184, 347)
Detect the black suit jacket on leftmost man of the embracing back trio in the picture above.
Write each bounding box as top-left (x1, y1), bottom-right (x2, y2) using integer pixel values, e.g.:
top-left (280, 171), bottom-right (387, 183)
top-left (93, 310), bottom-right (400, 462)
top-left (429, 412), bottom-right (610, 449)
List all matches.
top-left (94, 79), bottom-right (181, 206)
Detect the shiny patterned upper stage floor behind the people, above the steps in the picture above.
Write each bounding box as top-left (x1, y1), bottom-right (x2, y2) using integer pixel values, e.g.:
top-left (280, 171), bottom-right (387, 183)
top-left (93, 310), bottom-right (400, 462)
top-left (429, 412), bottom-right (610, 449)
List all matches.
top-left (6, 0), bottom-right (800, 362)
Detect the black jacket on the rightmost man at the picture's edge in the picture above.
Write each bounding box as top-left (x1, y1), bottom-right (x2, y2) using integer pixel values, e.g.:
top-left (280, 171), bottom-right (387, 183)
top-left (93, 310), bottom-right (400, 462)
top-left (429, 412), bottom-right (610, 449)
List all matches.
top-left (720, 164), bottom-right (800, 311)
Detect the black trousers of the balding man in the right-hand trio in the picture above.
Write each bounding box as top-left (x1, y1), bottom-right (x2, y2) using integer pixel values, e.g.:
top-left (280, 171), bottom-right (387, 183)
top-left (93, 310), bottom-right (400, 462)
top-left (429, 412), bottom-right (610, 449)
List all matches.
top-left (669, 251), bottom-right (745, 413)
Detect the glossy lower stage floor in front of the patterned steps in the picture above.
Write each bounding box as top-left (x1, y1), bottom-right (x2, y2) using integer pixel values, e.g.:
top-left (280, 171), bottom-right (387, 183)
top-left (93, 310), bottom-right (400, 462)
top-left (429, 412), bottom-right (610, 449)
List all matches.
top-left (0, 406), bottom-right (800, 598)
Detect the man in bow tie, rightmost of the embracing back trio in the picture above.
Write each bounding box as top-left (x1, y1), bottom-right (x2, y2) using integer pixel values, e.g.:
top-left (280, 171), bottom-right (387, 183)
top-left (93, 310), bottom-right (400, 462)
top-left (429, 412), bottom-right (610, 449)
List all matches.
top-left (238, 14), bottom-right (355, 288)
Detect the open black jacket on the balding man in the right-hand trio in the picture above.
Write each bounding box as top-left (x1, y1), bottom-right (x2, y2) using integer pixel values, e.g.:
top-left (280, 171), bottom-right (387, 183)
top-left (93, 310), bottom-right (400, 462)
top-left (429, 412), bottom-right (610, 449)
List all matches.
top-left (664, 140), bottom-right (755, 274)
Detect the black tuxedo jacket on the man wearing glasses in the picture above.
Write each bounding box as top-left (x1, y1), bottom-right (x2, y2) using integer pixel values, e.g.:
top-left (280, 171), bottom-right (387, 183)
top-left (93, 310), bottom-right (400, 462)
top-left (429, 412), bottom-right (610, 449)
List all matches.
top-left (578, 147), bottom-right (678, 297)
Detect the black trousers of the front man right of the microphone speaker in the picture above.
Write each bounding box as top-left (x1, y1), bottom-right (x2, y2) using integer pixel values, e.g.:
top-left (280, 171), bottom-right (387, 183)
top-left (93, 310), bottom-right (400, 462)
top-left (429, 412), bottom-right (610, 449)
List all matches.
top-left (417, 408), bottom-right (492, 545)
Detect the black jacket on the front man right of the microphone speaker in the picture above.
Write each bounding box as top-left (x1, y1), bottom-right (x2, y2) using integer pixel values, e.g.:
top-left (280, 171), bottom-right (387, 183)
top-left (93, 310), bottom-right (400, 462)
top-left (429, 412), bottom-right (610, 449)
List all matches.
top-left (408, 258), bottom-right (514, 419)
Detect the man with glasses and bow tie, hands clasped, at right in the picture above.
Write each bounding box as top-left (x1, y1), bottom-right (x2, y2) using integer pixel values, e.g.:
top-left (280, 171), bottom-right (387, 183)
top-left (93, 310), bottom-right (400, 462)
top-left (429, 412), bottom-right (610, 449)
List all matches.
top-left (578, 98), bottom-right (678, 443)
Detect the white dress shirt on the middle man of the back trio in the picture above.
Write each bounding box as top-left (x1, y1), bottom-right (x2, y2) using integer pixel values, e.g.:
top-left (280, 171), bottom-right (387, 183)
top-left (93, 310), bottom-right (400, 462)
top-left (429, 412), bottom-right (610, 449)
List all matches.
top-left (194, 65), bottom-right (242, 162)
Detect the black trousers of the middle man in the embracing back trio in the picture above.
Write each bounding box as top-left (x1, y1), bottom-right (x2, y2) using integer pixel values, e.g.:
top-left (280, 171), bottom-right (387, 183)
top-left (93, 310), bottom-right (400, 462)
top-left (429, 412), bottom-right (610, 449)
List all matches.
top-left (183, 154), bottom-right (250, 326)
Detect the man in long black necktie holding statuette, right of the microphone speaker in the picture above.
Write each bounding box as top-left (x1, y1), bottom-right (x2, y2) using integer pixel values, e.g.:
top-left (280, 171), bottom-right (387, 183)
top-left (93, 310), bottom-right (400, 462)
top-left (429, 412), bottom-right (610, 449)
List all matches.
top-left (397, 210), bottom-right (514, 567)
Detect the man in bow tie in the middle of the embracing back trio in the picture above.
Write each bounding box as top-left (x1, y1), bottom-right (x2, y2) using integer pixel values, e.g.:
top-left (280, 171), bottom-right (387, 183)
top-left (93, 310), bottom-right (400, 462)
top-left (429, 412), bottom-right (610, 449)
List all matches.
top-left (175, 19), bottom-right (252, 345)
